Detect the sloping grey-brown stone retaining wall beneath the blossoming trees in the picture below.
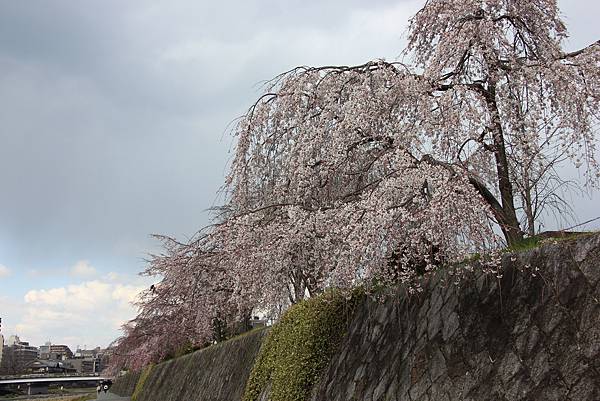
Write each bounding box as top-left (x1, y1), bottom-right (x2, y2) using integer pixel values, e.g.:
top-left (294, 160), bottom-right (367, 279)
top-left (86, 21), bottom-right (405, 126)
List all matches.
top-left (113, 234), bottom-right (600, 401)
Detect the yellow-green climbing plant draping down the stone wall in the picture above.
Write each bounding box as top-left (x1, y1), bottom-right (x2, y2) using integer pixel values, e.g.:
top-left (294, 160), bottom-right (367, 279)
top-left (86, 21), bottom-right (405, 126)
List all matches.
top-left (243, 290), bottom-right (363, 401)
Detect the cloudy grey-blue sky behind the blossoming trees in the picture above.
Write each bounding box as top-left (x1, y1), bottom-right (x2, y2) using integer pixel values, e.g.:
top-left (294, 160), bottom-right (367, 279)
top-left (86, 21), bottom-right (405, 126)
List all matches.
top-left (0, 0), bottom-right (600, 348)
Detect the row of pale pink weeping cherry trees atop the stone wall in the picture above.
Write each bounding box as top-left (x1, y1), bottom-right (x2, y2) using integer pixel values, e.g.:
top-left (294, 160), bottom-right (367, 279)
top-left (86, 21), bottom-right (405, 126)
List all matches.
top-left (110, 0), bottom-right (600, 368)
